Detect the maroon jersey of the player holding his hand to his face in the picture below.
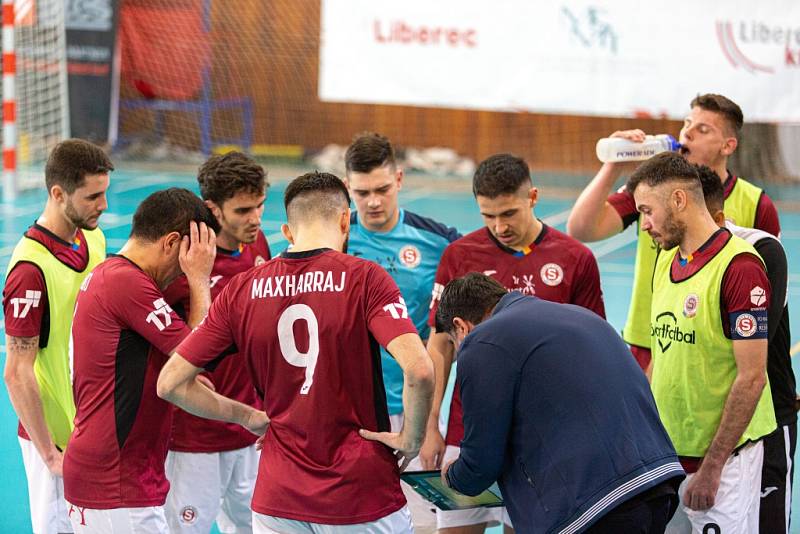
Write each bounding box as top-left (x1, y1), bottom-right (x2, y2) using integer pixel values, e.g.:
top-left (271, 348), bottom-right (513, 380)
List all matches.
top-left (64, 256), bottom-right (189, 509)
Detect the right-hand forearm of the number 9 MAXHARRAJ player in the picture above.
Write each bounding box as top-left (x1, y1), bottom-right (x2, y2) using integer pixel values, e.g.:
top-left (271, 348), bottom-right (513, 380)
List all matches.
top-left (403, 357), bottom-right (434, 449)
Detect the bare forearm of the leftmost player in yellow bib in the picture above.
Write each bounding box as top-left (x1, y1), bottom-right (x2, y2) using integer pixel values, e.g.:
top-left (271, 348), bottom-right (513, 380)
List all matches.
top-left (3, 336), bottom-right (58, 462)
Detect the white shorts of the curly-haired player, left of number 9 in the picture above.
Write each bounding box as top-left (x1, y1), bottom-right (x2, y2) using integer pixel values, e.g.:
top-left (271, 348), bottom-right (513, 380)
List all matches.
top-left (164, 445), bottom-right (259, 534)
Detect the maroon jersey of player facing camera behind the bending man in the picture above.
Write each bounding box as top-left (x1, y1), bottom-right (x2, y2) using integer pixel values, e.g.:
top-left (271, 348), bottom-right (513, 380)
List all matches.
top-left (429, 225), bottom-right (605, 446)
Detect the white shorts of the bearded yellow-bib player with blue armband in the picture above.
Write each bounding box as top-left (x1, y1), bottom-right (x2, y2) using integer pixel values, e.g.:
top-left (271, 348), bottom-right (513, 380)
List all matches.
top-left (666, 441), bottom-right (764, 534)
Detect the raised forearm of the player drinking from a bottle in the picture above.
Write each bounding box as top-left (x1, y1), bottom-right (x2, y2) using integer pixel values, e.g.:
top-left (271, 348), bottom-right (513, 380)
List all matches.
top-left (567, 163), bottom-right (622, 241)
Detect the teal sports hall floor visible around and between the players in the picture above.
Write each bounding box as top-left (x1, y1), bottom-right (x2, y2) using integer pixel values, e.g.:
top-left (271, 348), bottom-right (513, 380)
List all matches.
top-left (0, 171), bottom-right (800, 533)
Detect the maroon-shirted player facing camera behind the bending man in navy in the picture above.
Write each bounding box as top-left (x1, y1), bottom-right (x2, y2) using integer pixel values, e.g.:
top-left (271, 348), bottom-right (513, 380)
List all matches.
top-left (420, 154), bottom-right (605, 532)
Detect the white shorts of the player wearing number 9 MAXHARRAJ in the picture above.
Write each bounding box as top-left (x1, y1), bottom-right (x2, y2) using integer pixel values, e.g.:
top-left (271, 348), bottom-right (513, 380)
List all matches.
top-left (253, 506), bottom-right (414, 534)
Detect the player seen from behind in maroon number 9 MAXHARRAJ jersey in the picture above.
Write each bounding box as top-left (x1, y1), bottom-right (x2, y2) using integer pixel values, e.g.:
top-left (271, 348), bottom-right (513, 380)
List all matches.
top-left (158, 172), bottom-right (433, 533)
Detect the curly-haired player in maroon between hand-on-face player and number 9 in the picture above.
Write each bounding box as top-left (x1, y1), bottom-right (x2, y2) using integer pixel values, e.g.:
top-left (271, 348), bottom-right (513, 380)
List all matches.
top-left (164, 152), bottom-right (270, 534)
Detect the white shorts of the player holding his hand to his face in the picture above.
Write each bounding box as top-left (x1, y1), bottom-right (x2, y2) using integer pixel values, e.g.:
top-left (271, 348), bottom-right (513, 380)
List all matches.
top-left (67, 503), bottom-right (170, 534)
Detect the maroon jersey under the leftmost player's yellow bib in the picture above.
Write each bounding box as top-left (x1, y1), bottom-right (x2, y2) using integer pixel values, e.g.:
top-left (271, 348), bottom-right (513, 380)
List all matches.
top-left (3, 223), bottom-right (89, 440)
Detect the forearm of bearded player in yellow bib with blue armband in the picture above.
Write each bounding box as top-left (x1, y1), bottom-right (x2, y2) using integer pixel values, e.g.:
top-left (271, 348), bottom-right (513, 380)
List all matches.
top-left (703, 372), bottom-right (767, 469)
